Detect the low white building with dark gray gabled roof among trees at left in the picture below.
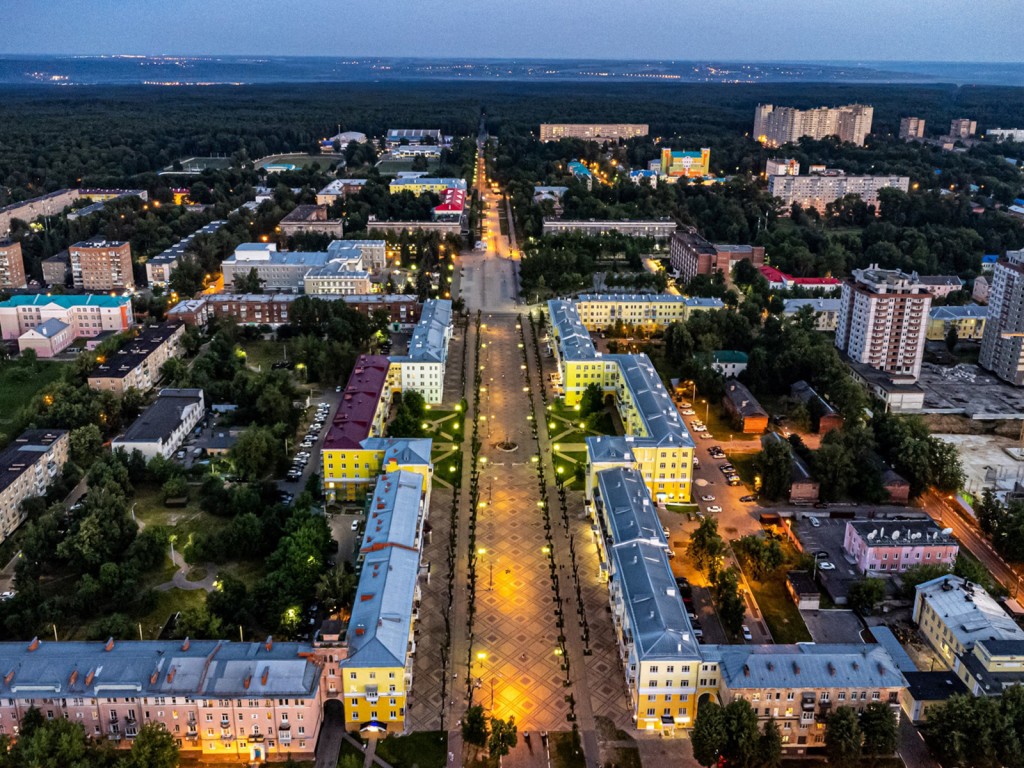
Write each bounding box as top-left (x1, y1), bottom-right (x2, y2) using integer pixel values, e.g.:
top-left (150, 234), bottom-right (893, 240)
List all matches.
top-left (111, 389), bottom-right (206, 461)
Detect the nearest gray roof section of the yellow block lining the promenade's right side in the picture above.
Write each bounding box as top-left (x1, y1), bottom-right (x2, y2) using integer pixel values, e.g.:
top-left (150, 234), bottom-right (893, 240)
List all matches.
top-left (611, 542), bottom-right (700, 662)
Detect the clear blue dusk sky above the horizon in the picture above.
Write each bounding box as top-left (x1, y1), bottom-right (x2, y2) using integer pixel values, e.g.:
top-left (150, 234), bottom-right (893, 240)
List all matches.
top-left (0, 0), bottom-right (1024, 62)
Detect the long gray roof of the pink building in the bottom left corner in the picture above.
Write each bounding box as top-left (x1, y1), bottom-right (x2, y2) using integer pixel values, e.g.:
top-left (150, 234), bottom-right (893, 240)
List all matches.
top-left (0, 640), bottom-right (319, 698)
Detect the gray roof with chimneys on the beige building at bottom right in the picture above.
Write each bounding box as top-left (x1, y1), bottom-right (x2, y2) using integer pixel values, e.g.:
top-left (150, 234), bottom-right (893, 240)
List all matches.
top-left (702, 643), bottom-right (906, 690)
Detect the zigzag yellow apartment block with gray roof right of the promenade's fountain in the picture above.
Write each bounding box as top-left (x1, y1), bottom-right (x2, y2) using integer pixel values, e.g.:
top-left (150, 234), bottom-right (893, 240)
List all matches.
top-left (548, 300), bottom-right (694, 503)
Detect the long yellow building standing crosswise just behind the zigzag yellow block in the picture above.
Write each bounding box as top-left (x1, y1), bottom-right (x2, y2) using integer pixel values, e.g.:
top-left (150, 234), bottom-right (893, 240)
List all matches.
top-left (575, 293), bottom-right (725, 331)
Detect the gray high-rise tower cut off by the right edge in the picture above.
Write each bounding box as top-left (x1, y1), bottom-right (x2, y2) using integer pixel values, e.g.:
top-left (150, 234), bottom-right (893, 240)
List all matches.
top-left (978, 251), bottom-right (1024, 387)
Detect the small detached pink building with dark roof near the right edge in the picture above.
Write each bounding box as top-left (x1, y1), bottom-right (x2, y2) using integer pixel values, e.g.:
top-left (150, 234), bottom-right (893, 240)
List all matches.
top-left (843, 520), bottom-right (959, 575)
